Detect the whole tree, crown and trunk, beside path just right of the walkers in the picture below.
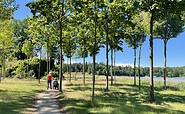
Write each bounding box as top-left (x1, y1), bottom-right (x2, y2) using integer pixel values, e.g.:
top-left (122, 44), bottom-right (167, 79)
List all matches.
top-left (26, 0), bottom-right (67, 92)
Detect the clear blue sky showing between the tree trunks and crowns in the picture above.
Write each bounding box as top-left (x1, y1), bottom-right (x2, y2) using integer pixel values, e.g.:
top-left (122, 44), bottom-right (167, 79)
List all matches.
top-left (14, 0), bottom-right (185, 66)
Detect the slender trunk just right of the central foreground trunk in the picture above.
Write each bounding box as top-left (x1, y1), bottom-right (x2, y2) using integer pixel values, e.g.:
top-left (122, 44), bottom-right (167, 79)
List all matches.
top-left (106, 19), bottom-right (109, 91)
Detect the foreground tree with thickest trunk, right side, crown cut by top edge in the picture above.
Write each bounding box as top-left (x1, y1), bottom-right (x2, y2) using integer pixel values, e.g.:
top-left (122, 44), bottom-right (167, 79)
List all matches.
top-left (139, 0), bottom-right (184, 102)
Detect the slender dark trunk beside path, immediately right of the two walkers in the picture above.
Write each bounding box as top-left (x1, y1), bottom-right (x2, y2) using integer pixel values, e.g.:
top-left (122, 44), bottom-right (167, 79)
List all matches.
top-left (59, 0), bottom-right (64, 92)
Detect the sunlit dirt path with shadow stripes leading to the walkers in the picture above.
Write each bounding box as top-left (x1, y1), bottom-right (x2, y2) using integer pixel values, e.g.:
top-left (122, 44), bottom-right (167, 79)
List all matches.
top-left (24, 85), bottom-right (65, 114)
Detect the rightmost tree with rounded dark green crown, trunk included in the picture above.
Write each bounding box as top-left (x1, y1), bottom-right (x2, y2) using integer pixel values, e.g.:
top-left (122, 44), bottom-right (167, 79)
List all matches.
top-left (155, 13), bottom-right (184, 89)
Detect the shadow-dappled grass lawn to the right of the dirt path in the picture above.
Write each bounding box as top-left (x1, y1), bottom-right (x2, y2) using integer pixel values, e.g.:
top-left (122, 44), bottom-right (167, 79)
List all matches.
top-left (59, 75), bottom-right (185, 114)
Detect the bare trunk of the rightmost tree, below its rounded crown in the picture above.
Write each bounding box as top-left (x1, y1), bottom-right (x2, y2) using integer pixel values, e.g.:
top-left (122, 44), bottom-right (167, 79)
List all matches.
top-left (164, 38), bottom-right (167, 89)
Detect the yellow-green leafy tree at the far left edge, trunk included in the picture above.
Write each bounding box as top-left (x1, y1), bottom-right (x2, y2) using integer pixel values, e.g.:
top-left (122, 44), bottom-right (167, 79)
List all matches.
top-left (0, 0), bottom-right (19, 79)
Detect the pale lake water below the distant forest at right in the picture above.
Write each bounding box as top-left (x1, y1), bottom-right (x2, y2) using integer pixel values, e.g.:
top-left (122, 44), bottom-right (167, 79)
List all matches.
top-left (140, 76), bottom-right (185, 82)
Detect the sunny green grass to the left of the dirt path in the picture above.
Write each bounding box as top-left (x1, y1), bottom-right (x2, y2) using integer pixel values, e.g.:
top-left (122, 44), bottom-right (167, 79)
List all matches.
top-left (0, 79), bottom-right (46, 114)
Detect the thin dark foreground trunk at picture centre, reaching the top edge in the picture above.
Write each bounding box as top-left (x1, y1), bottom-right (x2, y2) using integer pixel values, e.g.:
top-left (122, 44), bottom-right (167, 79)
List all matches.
top-left (92, 0), bottom-right (97, 105)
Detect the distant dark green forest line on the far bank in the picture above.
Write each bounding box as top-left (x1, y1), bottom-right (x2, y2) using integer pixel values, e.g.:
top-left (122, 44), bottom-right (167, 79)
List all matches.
top-left (63, 62), bottom-right (185, 77)
